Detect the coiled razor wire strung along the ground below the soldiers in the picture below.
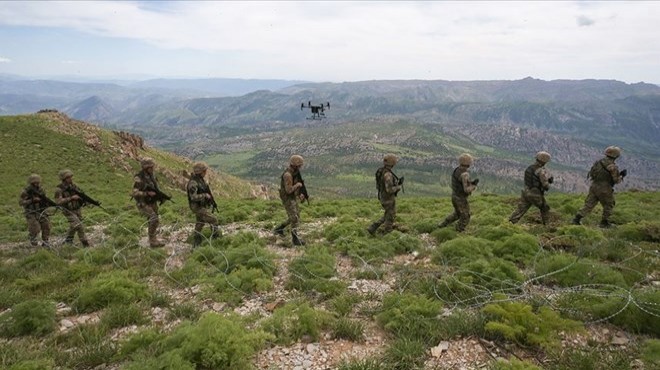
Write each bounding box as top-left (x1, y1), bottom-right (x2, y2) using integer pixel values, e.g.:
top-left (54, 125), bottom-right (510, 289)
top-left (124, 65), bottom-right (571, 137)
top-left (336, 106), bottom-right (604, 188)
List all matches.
top-left (1, 213), bottom-right (660, 324)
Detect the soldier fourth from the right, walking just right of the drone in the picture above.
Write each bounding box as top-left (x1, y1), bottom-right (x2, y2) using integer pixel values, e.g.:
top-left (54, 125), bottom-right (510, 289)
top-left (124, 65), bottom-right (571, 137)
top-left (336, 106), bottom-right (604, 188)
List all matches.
top-left (367, 154), bottom-right (403, 235)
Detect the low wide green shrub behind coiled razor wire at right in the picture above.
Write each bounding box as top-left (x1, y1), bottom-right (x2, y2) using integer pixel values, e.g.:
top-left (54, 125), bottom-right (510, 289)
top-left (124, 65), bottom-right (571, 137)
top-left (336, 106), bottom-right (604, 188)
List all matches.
top-left (535, 253), bottom-right (627, 287)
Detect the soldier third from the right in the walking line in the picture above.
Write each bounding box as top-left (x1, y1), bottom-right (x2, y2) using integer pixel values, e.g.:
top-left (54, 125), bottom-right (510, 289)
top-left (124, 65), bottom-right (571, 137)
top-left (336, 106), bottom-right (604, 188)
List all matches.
top-left (438, 153), bottom-right (479, 232)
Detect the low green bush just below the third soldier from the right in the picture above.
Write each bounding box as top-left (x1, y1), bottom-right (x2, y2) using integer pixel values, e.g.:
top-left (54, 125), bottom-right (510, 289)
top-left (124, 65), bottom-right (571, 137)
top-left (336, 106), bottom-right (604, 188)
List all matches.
top-left (432, 236), bottom-right (493, 266)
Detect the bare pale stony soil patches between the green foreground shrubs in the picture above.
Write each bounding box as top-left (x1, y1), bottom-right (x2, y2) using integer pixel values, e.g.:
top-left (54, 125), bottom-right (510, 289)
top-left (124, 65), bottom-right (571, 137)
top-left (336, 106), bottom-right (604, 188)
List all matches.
top-left (3, 220), bottom-right (643, 370)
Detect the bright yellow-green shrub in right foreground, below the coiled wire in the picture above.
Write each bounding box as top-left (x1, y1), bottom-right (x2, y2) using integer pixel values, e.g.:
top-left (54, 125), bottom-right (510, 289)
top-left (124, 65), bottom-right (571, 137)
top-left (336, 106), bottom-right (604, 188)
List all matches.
top-left (482, 302), bottom-right (582, 350)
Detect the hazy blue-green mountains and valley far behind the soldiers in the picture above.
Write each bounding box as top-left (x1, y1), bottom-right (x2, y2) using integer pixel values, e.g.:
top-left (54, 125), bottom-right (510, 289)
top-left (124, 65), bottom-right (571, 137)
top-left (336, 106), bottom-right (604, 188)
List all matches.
top-left (0, 78), bottom-right (660, 193)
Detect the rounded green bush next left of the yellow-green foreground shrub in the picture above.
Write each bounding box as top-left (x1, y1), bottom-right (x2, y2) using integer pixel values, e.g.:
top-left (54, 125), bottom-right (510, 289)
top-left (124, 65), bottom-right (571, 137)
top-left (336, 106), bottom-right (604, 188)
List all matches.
top-left (376, 293), bottom-right (442, 342)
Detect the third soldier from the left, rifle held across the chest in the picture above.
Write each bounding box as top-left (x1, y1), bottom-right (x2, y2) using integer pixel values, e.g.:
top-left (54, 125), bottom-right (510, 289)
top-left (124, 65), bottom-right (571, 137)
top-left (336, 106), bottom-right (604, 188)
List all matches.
top-left (132, 158), bottom-right (165, 248)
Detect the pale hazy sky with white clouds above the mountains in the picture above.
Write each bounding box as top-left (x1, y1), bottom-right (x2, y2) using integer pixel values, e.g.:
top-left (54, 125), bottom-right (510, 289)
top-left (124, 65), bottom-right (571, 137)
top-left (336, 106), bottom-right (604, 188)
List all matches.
top-left (0, 1), bottom-right (660, 83)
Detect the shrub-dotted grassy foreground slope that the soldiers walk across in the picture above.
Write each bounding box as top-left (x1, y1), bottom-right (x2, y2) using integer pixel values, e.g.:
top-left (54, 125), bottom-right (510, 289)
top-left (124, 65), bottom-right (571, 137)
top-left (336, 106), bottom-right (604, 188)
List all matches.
top-left (0, 181), bottom-right (660, 370)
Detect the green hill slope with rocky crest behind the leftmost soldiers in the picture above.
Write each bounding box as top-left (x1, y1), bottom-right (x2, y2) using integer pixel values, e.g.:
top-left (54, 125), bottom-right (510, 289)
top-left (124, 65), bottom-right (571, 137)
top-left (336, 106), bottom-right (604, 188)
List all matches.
top-left (0, 112), bottom-right (266, 240)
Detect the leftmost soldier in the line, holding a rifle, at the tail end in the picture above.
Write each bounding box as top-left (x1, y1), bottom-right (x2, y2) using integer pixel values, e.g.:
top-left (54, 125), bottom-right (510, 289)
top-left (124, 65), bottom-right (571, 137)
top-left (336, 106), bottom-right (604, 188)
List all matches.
top-left (18, 174), bottom-right (50, 247)
